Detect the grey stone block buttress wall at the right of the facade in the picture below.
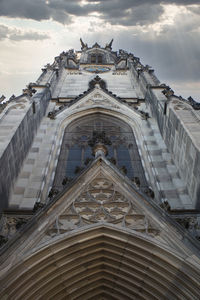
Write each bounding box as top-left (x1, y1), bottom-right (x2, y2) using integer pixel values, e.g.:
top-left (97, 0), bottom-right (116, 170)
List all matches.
top-left (146, 83), bottom-right (200, 209)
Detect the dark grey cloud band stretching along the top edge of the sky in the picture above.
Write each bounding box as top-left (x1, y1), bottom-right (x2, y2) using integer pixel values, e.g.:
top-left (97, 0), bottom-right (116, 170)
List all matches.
top-left (0, 0), bottom-right (199, 26)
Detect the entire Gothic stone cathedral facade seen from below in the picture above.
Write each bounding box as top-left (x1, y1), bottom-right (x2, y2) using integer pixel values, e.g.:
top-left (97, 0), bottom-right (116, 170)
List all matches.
top-left (0, 39), bottom-right (200, 300)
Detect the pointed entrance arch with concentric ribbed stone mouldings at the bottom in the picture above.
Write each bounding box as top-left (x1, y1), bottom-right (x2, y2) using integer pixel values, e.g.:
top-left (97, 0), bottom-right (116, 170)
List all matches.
top-left (0, 224), bottom-right (200, 300)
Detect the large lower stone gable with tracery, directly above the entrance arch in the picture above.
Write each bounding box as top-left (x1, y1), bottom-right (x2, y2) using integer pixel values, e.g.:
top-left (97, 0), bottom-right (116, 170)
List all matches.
top-left (0, 157), bottom-right (198, 261)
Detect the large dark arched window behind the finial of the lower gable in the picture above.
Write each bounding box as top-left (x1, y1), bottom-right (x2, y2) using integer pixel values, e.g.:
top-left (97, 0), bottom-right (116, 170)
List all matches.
top-left (54, 113), bottom-right (147, 190)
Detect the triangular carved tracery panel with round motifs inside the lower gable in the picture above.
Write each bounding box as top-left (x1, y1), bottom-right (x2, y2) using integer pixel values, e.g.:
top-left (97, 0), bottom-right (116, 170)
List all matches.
top-left (46, 177), bottom-right (160, 237)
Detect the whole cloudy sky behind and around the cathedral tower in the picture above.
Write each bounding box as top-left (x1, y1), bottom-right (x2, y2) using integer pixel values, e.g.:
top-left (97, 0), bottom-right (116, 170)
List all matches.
top-left (0, 0), bottom-right (200, 101)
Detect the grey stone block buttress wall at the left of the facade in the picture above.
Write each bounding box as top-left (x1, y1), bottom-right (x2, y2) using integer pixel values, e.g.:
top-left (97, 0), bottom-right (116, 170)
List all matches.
top-left (0, 88), bottom-right (50, 210)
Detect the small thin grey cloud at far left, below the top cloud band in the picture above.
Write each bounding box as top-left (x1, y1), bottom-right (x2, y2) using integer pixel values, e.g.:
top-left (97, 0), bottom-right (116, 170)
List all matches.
top-left (0, 24), bottom-right (49, 41)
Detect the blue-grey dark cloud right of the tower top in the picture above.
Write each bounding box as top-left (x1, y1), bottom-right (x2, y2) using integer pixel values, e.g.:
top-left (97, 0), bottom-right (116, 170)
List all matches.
top-left (114, 24), bottom-right (200, 82)
